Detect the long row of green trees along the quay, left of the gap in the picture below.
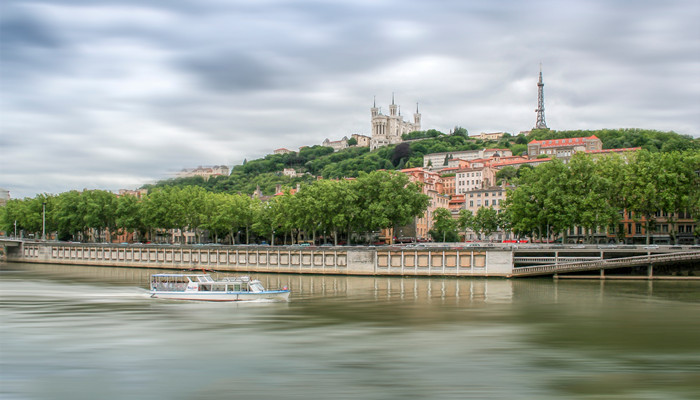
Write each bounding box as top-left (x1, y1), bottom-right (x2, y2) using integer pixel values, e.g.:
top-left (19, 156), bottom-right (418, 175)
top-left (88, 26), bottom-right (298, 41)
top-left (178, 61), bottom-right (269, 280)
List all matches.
top-left (0, 171), bottom-right (429, 243)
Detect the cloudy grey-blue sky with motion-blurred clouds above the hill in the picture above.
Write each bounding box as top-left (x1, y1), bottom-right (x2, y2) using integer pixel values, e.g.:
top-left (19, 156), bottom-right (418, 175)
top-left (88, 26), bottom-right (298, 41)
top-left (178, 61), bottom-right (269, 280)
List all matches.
top-left (0, 0), bottom-right (700, 198)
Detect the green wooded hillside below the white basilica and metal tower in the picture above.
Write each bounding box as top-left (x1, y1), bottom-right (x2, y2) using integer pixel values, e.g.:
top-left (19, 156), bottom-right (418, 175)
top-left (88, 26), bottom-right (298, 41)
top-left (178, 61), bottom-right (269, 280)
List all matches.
top-left (144, 127), bottom-right (700, 195)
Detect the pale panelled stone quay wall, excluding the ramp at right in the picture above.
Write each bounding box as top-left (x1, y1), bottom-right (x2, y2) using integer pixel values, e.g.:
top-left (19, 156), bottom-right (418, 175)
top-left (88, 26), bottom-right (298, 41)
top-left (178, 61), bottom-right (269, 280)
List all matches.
top-left (7, 242), bottom-right (513, 277)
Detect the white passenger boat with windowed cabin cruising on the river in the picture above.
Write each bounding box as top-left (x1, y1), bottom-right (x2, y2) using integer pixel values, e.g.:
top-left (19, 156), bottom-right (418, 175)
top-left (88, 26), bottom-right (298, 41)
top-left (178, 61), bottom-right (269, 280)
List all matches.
top-left (151, 274), bottom-right (289, 301)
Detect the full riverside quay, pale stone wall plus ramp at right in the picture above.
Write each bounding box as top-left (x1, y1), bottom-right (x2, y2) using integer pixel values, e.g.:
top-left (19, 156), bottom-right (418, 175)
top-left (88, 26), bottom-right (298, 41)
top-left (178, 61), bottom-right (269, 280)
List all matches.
top-left (0, 239), bottom-right (700, 278)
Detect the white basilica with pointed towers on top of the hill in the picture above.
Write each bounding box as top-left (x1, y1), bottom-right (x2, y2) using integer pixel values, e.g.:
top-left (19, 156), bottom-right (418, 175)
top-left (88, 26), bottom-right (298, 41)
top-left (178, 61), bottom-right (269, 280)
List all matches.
top-left (370, 95), bottom-right (421, 150)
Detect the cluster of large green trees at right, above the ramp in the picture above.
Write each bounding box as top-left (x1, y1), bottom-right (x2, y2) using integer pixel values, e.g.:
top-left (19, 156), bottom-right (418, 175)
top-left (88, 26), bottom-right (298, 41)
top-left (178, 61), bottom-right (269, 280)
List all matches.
top-left (504, 150), bottom-right (700, 243)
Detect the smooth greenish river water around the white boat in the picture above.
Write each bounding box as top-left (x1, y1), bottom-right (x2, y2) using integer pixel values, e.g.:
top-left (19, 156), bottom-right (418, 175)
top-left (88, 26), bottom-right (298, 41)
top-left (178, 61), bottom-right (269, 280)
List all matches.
top-left (0, 263), bottom-right (700, 400)
